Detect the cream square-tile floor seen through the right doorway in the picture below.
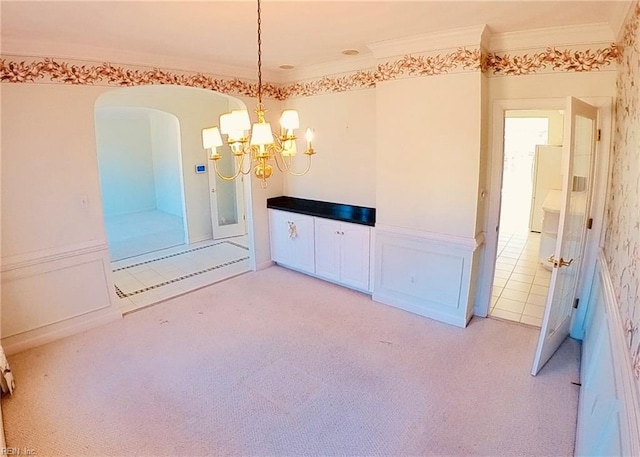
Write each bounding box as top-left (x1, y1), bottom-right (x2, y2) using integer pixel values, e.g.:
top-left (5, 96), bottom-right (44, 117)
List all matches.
top-left (489, 232), bottom-right (551, 327)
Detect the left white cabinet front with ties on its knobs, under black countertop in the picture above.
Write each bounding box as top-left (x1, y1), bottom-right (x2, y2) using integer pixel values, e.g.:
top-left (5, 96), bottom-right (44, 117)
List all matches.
top-left (269, 210), bottom-right (315, 273)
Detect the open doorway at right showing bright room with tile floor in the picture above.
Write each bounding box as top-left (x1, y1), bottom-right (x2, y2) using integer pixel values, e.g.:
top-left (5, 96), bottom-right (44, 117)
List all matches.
top-left (489, 110), bottom-right (563, 327)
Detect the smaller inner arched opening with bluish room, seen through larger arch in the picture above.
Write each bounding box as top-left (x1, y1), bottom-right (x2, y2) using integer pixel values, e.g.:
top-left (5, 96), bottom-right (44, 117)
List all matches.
top-left (96, 107), bottom-right (188, 262)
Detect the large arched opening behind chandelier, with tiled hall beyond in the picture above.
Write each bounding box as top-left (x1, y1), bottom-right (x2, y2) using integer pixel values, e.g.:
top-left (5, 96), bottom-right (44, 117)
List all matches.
top-left (95, 86), bottom-right (254, 313)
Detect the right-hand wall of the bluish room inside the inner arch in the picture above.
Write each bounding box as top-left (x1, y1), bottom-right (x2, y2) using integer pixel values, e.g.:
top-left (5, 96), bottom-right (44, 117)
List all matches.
top-left (149, 111), bottom-right (184, 217)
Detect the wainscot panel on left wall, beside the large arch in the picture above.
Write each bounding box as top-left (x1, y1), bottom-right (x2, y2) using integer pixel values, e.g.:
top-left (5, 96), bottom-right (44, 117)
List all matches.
top-left (2, 245), bottom-right (122, 354)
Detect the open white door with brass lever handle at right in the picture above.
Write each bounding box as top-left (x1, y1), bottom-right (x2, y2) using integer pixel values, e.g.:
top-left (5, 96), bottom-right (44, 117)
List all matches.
top-left (531, 97), bottom-right (598, 376)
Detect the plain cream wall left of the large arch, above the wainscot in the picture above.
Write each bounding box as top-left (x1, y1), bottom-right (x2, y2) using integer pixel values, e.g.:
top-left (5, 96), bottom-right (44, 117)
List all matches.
top-left (2, 84), bottom-right (105, 259)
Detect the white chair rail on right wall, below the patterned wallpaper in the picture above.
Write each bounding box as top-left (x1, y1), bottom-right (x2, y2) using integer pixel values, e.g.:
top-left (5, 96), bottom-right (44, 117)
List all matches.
top-left (598, 250), bottom-right (640, 455)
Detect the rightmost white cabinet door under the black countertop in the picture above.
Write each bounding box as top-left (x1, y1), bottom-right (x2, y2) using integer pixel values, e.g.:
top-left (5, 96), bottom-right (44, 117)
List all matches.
top-left (340, 224), bottom-right (371, 290)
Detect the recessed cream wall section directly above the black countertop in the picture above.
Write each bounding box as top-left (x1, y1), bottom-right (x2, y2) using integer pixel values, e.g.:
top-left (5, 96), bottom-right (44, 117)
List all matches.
top-left (282, 89), bottom-right (376, 207)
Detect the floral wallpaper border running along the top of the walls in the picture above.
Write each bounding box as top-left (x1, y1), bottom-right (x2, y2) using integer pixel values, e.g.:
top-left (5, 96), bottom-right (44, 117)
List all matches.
top-left (0, 44), bottom-right (619, 100)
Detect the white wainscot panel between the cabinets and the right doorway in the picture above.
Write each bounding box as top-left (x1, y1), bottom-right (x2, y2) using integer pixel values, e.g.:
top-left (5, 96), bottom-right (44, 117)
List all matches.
top-left (373, 228), bottom-right (482, 327)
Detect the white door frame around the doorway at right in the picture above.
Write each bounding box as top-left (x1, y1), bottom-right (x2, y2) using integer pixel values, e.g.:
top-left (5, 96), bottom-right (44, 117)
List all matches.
top-left (475, 97), bottom-right (613, 339)
